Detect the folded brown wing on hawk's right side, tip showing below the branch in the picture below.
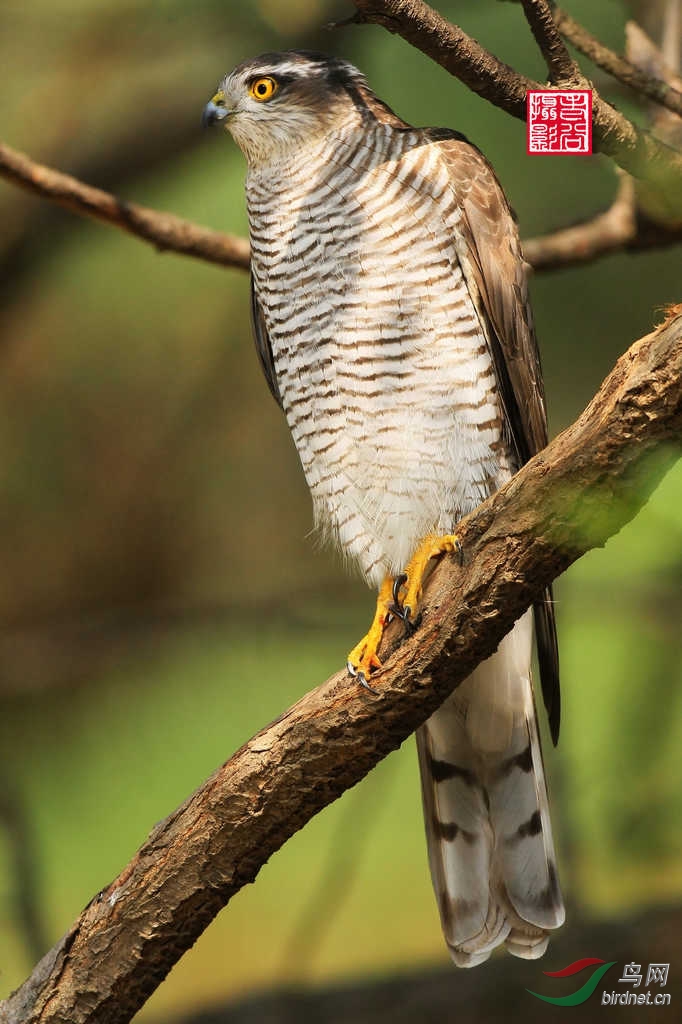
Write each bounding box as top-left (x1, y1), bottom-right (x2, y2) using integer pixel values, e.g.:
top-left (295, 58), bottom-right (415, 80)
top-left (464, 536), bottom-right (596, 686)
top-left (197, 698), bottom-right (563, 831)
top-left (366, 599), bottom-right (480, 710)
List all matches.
top-left (426, 129), bottom-right (560, 743)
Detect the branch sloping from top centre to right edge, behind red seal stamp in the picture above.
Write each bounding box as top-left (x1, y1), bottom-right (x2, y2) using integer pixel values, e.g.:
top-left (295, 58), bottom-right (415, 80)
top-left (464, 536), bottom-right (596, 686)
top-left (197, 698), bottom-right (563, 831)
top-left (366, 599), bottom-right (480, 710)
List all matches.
top-left (353, 0), bottom-right (682, 211)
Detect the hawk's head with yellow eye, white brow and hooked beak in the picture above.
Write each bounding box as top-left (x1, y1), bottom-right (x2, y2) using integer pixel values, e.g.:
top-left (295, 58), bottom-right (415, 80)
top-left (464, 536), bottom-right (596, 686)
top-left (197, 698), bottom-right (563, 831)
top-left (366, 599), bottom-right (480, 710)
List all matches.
top-left (203, 50), bottom-right (366, 164)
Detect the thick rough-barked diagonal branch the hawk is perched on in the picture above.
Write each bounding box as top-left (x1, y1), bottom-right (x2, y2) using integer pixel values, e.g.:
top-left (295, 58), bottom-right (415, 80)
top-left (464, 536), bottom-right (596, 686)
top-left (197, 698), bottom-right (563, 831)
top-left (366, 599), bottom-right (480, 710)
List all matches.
top-left (0, 306), bottom-right (682, 1024)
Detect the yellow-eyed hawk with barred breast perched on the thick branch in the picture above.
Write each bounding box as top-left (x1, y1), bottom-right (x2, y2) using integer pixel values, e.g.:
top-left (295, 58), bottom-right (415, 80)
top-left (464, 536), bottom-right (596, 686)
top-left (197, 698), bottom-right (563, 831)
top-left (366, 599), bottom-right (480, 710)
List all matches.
top-left (204, 50), bottom-right (564, 967)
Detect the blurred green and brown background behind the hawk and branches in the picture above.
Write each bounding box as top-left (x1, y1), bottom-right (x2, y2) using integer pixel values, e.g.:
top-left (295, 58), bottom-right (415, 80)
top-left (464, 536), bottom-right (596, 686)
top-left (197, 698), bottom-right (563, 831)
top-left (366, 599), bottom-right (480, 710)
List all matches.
top-left (0, 0), bottom-right (682, 1022)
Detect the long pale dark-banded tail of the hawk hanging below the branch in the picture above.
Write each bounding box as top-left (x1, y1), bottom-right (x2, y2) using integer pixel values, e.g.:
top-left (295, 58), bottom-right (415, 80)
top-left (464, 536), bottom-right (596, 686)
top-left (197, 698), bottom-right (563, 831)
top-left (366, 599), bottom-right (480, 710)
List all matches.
top-left (417, 613), bottom-right (564, 967)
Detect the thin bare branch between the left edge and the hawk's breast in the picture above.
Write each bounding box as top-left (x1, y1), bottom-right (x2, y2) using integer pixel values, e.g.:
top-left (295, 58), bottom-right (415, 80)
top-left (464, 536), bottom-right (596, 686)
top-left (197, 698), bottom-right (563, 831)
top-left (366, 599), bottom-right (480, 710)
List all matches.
top-left (0, 143), bottom-right (249, 268)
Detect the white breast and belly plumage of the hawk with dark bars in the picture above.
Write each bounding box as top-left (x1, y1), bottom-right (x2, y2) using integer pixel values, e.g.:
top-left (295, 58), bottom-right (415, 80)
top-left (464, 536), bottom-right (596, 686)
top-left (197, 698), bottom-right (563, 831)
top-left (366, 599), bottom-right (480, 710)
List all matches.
top-left (247, 116), bottom-right (510, 585)
